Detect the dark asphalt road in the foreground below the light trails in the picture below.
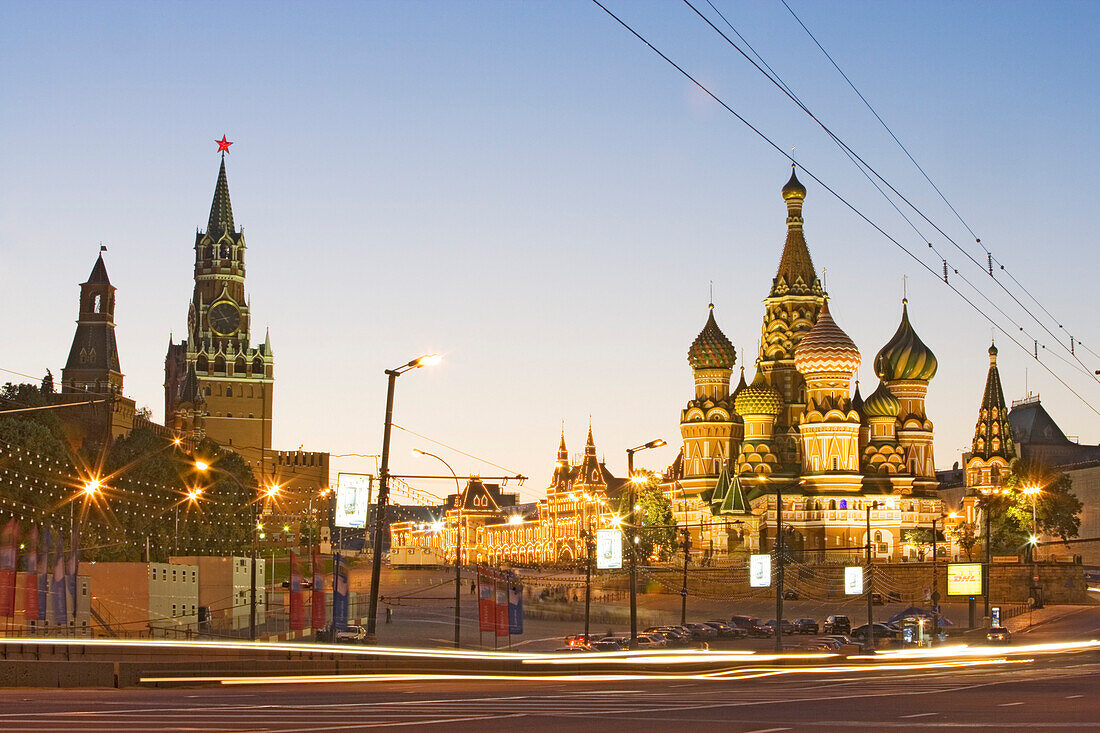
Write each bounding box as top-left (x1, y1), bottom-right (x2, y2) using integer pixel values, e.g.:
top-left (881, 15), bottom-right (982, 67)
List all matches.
top-left (0, 653), bottom-right (1100, 733)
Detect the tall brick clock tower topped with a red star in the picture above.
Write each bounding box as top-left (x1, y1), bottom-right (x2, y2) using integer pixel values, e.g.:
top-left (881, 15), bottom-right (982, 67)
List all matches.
top-left (164, 146), bottom-right (275, 463)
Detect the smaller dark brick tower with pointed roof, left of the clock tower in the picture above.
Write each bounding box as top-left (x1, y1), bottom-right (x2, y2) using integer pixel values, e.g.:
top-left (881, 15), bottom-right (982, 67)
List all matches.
top-left (62, 253), bottom-right (122, 395)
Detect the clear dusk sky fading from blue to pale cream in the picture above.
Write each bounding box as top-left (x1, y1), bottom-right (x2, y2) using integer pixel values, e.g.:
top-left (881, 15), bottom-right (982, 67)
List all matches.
top-left (0, 0), bottom-right (1100, 501)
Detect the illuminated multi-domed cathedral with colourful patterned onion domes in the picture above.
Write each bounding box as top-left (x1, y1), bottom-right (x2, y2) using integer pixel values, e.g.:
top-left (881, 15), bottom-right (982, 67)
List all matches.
top-left (664, 172), bottom-right (947, 561)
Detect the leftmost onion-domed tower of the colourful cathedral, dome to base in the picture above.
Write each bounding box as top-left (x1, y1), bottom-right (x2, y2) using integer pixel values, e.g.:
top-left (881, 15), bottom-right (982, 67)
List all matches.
top-left (680, 304), bottom-right (744, 495)
